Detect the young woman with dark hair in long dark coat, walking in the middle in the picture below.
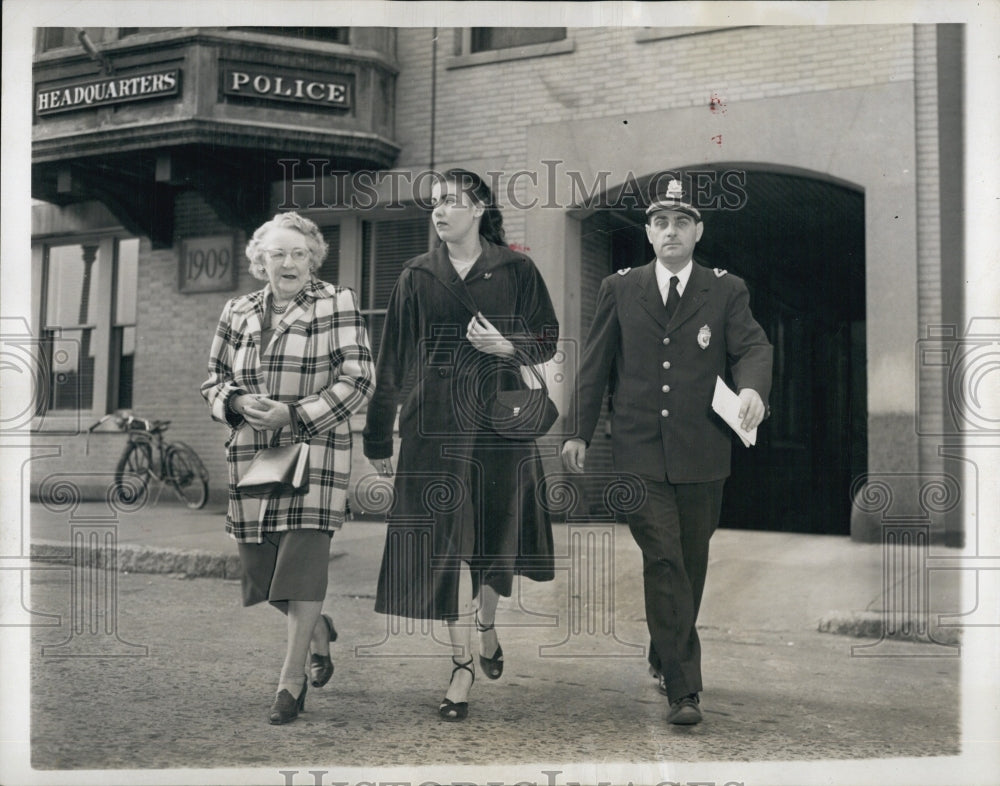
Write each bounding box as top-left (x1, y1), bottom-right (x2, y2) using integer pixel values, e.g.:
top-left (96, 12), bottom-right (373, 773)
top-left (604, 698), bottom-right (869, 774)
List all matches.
top-left (364, 170), bottom-right (559, 720)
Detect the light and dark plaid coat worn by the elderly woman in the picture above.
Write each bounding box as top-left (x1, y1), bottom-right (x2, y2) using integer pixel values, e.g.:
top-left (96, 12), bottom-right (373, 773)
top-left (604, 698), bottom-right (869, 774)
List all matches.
top-left (201, 279), bottom-right (374, 543)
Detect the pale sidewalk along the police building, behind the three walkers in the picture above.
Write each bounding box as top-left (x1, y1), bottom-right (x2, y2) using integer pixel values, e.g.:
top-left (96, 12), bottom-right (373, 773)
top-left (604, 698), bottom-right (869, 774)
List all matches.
top-left (30, 500), bottom-right (966, 644)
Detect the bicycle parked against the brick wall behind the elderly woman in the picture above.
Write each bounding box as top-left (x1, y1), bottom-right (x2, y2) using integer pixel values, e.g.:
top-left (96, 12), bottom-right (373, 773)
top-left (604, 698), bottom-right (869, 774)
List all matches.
top-left (87, 410), bottom-right (208, 510)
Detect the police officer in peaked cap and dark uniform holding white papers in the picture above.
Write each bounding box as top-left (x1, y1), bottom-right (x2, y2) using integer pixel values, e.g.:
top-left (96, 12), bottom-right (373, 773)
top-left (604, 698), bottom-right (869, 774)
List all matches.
top-left (562, 180), bottom-right (772, 725)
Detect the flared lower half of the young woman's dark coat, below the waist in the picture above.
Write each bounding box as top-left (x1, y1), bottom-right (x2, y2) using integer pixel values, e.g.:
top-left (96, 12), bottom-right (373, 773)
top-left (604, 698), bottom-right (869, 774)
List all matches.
top-left (375, 434), bottom-right (555, 620)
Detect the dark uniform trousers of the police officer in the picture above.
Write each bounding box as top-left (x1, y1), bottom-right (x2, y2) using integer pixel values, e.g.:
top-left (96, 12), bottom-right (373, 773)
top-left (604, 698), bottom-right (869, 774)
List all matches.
top-left (628, 479), bottom-right (725, 701)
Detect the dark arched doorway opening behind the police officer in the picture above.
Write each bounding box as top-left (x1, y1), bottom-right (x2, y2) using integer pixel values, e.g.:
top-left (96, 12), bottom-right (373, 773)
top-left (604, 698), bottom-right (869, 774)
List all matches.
top-left (581, 165), bottom-right (868, 535)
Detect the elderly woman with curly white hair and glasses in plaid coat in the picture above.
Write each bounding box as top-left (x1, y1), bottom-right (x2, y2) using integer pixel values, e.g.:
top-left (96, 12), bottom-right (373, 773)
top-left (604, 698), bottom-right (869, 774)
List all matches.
top-left (201, 208), bottom-right (374, 724)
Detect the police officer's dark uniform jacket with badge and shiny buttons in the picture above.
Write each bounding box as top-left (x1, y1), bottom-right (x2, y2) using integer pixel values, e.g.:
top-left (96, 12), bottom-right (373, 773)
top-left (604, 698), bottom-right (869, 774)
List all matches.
top-left (574, 260), bottom-right (772, 483)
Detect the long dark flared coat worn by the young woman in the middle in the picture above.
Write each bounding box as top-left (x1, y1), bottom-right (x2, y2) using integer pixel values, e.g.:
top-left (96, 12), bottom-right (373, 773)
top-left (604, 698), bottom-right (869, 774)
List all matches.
top-left (364, 239), bottom-right (559, 619)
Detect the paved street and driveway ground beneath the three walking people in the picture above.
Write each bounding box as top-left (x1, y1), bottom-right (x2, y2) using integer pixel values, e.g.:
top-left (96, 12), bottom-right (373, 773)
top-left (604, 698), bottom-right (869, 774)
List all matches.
top-left (23, 523), bottom-right (961, 783)
